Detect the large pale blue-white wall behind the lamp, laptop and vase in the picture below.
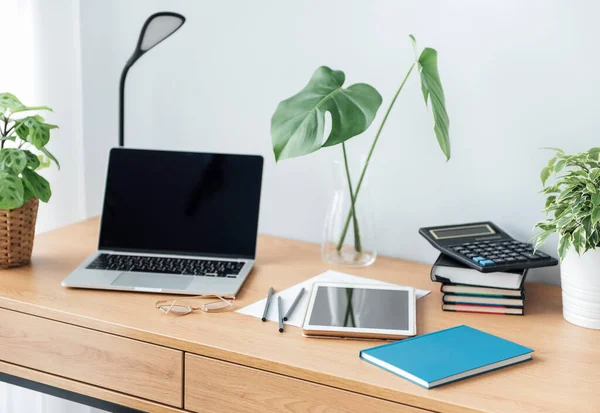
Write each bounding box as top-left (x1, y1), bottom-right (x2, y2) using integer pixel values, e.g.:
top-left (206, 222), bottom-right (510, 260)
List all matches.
top-left (81, 0), bottom-right (600, 283)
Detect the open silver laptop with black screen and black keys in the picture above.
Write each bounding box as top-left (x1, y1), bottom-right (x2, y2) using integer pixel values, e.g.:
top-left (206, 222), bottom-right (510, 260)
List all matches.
top-left (62, 148), bottom-right (263, 298)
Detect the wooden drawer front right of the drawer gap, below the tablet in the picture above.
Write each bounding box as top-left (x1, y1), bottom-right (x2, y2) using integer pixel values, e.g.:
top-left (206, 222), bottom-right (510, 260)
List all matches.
top-left (185, 353), bottom-right (426, 413)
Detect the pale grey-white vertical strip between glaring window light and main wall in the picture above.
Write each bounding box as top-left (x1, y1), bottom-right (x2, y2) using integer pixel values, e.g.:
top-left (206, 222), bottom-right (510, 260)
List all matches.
top-left (31, 0), bottom-right (85, 231)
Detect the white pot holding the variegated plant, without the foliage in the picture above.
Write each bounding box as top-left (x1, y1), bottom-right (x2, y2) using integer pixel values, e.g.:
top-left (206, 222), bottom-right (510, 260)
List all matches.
top-left (560, 249), bottom-right (600, 329)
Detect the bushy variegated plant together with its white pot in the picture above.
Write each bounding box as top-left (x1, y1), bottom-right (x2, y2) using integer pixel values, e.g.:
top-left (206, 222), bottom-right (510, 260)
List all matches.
top-left (535, 148), bottom-right (600, 329)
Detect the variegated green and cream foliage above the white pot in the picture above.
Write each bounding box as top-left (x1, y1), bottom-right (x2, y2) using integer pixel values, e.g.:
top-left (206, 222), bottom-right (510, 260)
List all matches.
top-left (534, 148), bottom-right (600, 260)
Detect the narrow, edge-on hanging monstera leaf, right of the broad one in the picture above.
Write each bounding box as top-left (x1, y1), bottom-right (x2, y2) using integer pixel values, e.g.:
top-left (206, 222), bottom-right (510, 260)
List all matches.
top-left (418, 46), bottom-right (450, 160)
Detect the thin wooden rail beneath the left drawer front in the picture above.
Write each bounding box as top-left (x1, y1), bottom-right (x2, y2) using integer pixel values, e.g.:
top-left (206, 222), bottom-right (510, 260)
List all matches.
top-left (0, 361), bottom-right (185, 413)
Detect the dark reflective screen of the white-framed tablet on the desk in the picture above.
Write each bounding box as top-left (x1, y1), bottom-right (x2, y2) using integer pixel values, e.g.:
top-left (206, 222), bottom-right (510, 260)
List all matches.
top-left (309, 286), bottom-right (410, 330)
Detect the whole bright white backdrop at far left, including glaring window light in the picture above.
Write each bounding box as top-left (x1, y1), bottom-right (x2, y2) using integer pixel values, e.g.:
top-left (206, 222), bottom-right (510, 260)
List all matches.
top-left (0, 0), bottom-right (85, 232)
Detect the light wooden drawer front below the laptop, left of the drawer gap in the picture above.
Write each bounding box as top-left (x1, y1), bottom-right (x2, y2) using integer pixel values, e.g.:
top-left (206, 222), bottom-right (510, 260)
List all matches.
top-left (0, 309), bottom-right (183, 407)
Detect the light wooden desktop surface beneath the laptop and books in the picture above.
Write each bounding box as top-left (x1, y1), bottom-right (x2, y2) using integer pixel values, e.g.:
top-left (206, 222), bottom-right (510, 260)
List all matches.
top-left (0, 219), bottom-right (600, 413)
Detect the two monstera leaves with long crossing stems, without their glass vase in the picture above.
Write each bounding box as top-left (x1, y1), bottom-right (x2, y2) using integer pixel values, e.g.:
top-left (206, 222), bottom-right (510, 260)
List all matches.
top-left (271, 35), bottom-right (450, 252)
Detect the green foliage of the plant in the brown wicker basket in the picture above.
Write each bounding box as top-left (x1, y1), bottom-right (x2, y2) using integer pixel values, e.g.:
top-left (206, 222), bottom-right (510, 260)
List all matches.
top-left (0, 93), bottom-right (60, 209)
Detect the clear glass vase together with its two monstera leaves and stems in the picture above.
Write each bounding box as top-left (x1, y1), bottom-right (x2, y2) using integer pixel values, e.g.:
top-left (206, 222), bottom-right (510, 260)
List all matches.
top-left (271, 35), bottom-right (450, 267)
